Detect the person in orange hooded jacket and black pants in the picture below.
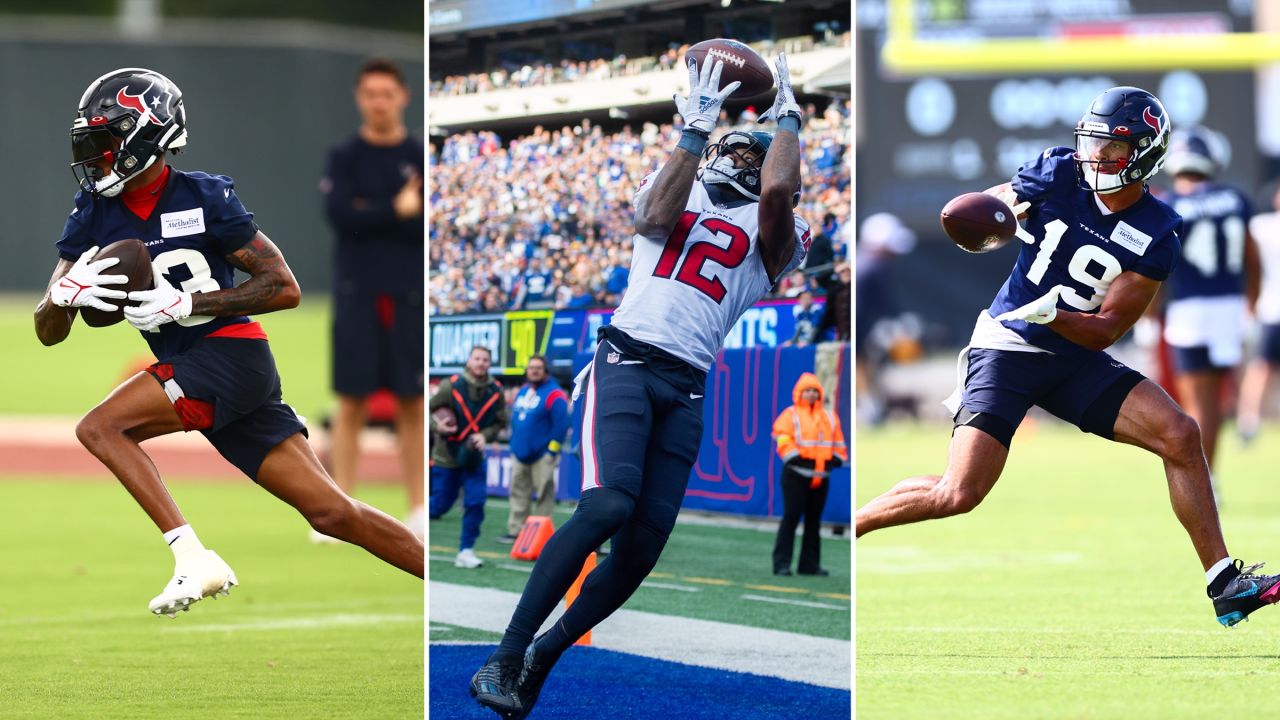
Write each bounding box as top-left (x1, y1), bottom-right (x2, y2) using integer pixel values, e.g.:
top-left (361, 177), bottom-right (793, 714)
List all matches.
top-left (773, 373), bottom-right (849, 575)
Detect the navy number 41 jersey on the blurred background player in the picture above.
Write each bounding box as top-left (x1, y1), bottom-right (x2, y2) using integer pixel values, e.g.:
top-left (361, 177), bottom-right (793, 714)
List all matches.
top-left (1167, 182), bottom-right (1253, 300)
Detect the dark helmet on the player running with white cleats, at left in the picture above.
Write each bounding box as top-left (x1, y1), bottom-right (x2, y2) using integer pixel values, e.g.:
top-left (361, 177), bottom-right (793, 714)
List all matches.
top-left (72, 68), bottom-right (187, 197)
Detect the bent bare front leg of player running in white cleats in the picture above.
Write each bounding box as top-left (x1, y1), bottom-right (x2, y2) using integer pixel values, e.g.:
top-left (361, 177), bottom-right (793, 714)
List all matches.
top-left (76, 373), bottom-right (187, 532)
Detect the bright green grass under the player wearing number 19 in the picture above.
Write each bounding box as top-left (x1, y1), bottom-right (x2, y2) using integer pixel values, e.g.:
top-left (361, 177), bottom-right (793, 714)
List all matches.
top-left (856, 421), bottom-right (1280, 720)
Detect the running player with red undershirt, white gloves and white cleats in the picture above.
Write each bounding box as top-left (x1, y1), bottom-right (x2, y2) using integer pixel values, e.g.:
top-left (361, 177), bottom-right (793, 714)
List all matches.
top-left (36, 68), bottom-right (422, 618)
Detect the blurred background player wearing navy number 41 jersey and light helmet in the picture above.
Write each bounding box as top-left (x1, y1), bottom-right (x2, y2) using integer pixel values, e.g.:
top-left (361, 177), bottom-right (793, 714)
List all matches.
top-left (1165, 127), bottom-right (1261, 473)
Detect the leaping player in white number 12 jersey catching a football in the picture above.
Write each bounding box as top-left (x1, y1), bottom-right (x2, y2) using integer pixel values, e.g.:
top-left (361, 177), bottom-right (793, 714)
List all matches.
top-left (471, 54), bottom-right (809, 717)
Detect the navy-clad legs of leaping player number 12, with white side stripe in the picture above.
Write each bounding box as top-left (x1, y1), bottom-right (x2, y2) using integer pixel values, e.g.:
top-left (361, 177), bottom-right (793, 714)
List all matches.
top-left (494, 328), bottom-right (705, 662)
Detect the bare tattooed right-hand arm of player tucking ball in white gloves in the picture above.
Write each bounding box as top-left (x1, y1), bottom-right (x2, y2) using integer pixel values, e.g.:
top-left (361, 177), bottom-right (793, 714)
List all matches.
top-left (191, 232), bottom-right (302, 316)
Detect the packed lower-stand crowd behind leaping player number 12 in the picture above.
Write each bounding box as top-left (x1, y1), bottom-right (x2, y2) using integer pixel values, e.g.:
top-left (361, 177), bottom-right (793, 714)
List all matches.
top-left (428, 100), bottom-right (851, 315)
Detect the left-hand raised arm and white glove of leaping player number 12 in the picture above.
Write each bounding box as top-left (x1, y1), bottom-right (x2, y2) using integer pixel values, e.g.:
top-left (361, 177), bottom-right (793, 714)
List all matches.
top-left (635, 60), bottom-right (742, 238)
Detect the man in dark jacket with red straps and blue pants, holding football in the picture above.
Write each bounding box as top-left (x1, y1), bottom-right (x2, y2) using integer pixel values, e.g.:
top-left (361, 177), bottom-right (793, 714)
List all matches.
top-left (429, 345), bottom-right (507, 569)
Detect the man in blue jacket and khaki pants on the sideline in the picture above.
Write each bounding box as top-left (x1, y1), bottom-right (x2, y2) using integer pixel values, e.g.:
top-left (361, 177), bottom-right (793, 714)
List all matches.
top-left (498, 355), bottom-right (568, 543)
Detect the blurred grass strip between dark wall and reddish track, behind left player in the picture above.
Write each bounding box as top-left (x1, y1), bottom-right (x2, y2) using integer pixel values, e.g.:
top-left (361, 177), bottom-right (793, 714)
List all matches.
top-left (0, 293), bottom-right (333, 419)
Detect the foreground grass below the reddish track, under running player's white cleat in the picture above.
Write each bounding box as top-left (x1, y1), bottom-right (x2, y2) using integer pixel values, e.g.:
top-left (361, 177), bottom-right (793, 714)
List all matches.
top-left (0, 478), bottom-right (424, 720)
